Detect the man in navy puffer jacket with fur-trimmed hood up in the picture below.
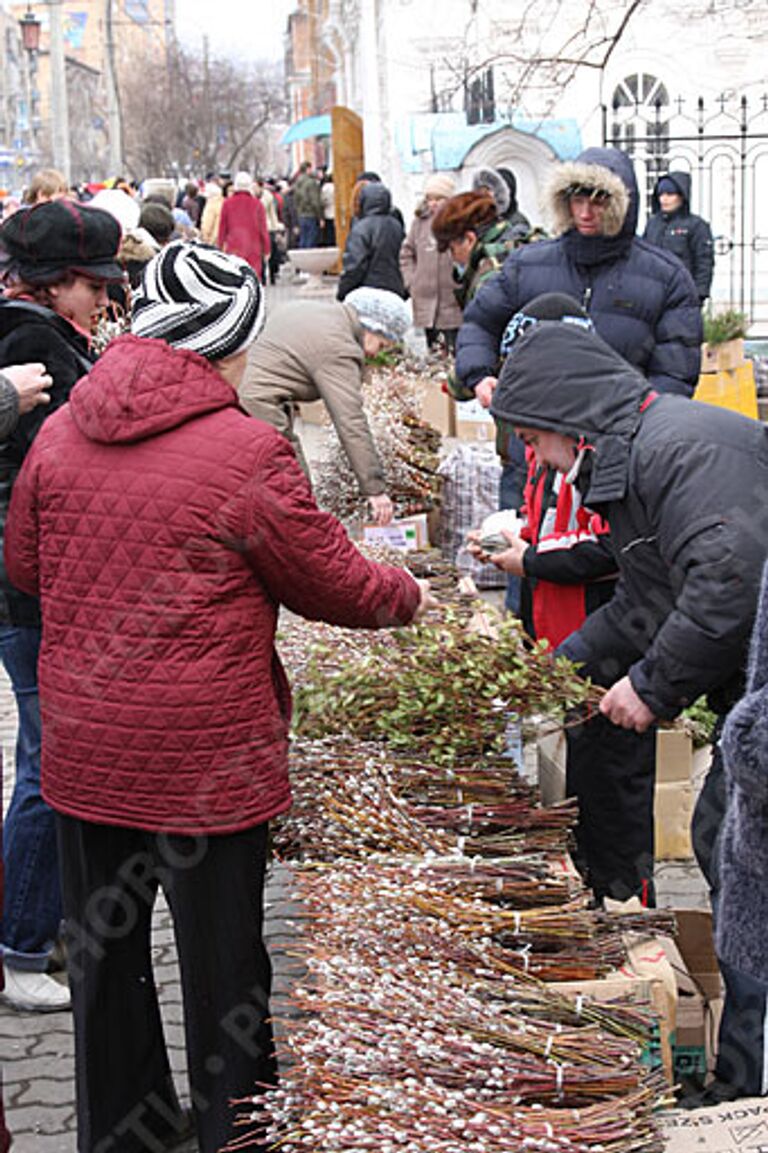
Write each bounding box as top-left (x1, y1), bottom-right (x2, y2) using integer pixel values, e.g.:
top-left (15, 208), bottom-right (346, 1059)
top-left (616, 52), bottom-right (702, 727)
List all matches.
top-left (455, 148), bottom-right (702, 406)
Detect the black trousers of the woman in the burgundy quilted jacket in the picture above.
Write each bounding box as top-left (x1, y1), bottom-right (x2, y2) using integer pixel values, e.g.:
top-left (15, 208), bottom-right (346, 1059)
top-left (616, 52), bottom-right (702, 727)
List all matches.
top-left (58, 816), bottom-right (277, 1153)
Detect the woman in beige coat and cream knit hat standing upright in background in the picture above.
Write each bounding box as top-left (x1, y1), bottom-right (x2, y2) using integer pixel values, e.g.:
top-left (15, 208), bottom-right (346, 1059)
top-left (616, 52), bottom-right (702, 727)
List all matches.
top-left (400, 173), bottom-right (461, 351)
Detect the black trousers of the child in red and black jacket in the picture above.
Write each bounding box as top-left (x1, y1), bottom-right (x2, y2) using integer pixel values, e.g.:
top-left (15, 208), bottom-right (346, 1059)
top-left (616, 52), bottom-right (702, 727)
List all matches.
top-left (566, 714), bottom-right (656, 906)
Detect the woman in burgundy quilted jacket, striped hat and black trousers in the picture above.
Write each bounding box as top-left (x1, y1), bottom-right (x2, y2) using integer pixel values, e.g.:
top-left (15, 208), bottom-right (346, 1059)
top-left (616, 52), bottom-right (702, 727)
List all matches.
top-left (6, 242), bottom-right (429, 1153)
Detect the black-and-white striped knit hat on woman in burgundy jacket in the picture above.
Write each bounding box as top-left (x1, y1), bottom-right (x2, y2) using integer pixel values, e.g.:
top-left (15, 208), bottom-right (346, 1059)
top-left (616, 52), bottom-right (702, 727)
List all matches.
top-left (131, 240), bottom-right (264, 361)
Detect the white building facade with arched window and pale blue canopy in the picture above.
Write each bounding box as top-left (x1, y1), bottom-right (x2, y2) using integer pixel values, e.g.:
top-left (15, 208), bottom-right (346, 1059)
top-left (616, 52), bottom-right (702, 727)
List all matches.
top-left (322, 0), bottom-right (768, 320)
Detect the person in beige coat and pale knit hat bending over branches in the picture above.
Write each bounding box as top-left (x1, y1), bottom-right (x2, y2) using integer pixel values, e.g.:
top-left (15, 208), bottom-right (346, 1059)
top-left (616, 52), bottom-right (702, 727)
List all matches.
top-left (239, 288), bottom-right (411, 525)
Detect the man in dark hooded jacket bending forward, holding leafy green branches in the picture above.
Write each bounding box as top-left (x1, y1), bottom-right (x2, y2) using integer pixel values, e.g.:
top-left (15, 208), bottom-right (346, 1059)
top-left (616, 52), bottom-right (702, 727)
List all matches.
top-left (491, 311), bottom-right (768, 1103)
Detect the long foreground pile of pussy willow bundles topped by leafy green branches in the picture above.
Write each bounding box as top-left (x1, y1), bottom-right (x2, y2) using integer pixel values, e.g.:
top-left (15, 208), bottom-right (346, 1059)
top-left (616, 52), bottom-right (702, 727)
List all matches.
top-left (250, 546), bottom-right (671, 1153)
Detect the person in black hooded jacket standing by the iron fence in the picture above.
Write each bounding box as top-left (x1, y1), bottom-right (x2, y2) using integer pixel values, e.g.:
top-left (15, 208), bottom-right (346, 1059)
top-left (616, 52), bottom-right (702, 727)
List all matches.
top-left (643, 172), bottom-right (715, 303)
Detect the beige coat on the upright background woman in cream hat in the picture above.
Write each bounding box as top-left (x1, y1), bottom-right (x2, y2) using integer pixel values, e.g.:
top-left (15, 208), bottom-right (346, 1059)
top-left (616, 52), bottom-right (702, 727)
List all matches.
top-left (400, 206), bottom-right (461, 329)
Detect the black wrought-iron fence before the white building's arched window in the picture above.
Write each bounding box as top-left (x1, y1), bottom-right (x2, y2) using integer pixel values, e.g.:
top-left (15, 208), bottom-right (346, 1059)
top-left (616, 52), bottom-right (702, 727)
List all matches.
top-left (603, 90), bottom-right (768, 338)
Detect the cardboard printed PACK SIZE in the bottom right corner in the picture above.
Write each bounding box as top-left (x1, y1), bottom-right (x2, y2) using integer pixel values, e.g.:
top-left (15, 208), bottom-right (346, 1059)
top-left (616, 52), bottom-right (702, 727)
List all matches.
top-left (657, 1097), bottom-right (768, 1153)
